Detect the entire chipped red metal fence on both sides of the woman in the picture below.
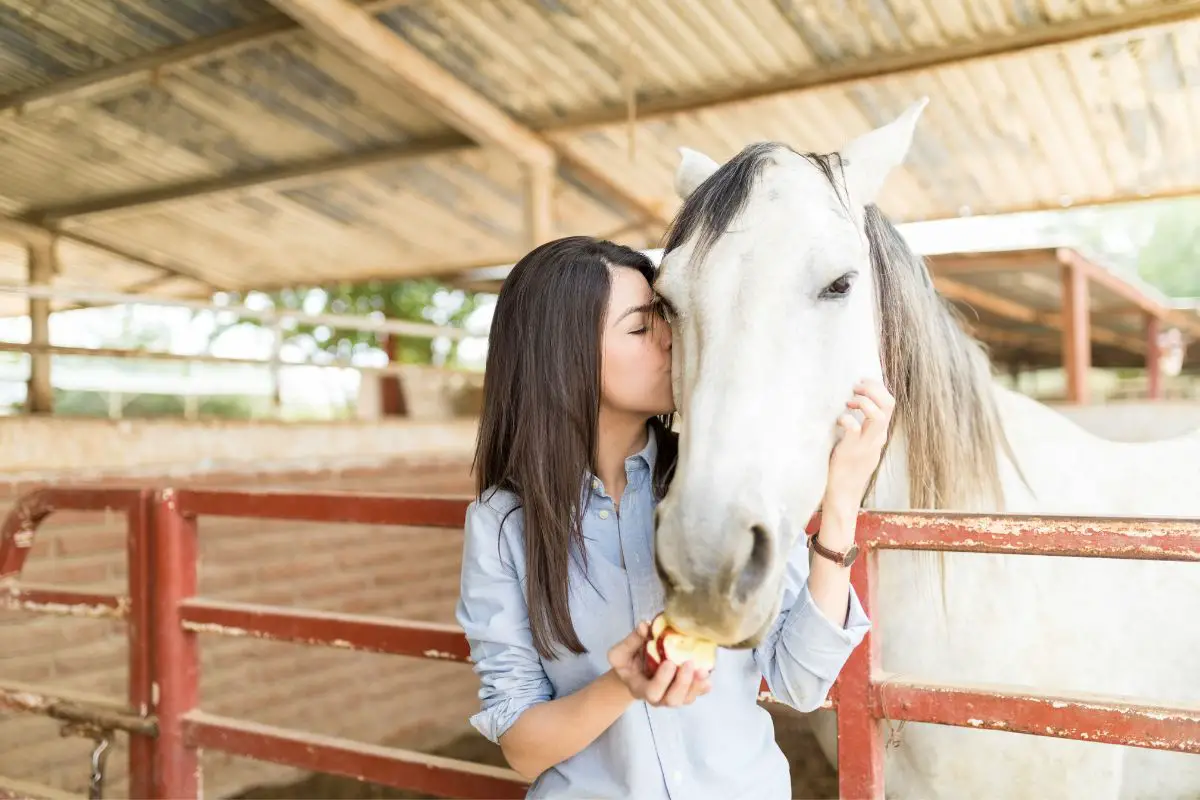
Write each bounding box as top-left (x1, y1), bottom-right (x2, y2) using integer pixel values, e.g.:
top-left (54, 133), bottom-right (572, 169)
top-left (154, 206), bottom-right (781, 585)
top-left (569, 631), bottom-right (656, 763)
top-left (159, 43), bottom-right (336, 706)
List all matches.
top-left (0, 488), bottom-right (1200, 799)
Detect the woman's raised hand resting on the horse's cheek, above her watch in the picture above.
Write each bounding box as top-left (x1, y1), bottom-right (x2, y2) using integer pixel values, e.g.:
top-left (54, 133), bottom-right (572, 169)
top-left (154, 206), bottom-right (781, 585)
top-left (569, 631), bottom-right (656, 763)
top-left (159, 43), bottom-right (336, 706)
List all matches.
top-left (822, 379), bottom-right (895, 515)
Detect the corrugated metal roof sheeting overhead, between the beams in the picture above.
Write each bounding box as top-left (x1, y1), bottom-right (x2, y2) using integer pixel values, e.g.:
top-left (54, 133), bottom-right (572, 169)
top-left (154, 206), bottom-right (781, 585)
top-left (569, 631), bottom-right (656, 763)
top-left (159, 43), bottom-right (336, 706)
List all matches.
top-left (0, 0), bottom-right (1200, 297)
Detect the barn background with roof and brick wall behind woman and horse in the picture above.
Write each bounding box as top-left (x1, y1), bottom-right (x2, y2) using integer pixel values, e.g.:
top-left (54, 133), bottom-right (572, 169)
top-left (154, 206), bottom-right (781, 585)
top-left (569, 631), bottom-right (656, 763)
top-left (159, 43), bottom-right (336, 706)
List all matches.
top-left (0, 0), bottom-right (1200, 796)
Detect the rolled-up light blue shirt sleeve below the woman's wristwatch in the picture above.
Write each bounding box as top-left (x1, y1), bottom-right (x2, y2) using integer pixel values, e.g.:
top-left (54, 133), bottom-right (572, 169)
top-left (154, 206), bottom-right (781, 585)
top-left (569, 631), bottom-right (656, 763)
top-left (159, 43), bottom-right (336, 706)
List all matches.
top-left (755, 534), bottom-right (871, 711)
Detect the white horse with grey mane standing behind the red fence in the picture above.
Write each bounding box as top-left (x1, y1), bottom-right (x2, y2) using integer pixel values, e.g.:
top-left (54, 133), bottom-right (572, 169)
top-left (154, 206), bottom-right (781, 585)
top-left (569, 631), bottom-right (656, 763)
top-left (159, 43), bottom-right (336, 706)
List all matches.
top-left (656, 100), bottom-right (1200, 800)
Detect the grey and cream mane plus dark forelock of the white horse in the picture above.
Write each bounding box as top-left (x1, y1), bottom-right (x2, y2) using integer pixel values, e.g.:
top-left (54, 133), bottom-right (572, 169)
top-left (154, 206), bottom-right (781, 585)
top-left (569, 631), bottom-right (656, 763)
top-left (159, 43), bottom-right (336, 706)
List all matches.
top-left (664, 142), bottom-right (1016, 510)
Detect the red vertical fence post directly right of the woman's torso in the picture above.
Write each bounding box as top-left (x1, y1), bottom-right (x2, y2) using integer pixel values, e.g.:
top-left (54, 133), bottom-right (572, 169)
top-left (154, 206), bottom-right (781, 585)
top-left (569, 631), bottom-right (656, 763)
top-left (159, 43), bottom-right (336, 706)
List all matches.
top-left (834, 544), bottom-right (883, 800)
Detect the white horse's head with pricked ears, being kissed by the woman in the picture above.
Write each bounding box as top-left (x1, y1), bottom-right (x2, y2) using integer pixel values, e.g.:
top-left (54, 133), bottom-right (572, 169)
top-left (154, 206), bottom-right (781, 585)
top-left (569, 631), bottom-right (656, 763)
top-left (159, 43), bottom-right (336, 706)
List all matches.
top-left (655, 98), bottom-right (928, 646)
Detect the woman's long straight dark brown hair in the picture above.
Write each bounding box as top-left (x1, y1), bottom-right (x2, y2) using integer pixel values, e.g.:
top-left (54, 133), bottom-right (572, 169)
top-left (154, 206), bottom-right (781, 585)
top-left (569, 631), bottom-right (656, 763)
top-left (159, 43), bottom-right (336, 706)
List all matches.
top-left (474, 236), bottom-right (677, 658)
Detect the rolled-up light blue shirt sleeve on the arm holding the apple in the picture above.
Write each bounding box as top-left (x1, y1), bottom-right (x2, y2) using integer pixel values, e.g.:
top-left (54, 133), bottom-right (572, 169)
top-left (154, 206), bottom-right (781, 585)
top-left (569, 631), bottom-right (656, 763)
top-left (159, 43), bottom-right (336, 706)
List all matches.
top-left (455, 500), bottom-right (553, 744)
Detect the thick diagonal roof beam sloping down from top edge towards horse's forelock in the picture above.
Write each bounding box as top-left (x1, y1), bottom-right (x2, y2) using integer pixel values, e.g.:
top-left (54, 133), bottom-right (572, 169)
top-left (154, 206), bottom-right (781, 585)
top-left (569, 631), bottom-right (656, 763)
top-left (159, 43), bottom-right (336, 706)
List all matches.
top-left (261, 0), bottom-right (668, 223)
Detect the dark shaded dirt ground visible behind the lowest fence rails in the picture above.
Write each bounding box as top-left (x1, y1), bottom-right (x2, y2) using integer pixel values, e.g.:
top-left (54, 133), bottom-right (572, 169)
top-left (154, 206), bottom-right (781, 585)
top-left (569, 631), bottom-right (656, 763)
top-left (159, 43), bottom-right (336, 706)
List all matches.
top-left (234, 703), bottom-right (838, 800)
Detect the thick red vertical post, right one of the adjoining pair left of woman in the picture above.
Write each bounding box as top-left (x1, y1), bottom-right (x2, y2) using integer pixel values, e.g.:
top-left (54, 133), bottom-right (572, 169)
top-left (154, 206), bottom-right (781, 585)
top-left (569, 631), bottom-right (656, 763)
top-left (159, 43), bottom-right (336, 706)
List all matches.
top-left (152, 489), bottom-right (200, 799)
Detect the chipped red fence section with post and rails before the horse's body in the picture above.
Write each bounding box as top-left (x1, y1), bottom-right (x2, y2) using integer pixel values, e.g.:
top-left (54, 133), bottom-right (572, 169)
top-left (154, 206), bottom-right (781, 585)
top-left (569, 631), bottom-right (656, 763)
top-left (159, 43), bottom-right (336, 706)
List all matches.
top-left (840, 512), bottom-right (1200, 800)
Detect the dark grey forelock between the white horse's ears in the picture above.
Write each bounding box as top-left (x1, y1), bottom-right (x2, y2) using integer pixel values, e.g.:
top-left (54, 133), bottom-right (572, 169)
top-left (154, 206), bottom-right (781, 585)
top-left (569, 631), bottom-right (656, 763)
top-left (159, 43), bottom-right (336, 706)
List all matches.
top-left (662, 142), bottom-right (845, 258)
